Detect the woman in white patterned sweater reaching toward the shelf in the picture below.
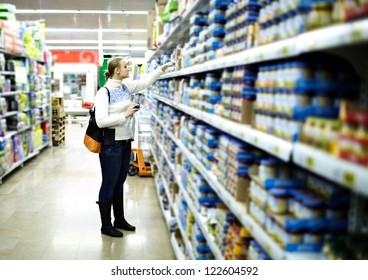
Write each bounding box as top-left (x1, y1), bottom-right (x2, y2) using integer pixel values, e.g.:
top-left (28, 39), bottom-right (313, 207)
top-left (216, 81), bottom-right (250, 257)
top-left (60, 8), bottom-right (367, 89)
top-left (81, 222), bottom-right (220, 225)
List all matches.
top-left (95, 57), bottom-right (173, 237)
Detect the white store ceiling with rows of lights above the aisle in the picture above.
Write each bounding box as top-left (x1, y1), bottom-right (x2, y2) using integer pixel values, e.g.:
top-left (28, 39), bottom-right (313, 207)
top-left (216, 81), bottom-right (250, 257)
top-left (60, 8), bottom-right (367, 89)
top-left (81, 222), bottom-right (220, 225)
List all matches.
top-left (7, 0), bottom-right (155, 57)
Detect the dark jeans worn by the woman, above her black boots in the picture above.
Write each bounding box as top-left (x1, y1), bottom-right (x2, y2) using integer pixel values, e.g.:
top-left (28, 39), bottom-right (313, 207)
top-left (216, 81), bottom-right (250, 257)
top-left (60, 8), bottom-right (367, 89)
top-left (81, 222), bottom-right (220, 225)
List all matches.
top-left (98, 140), bottom-right (131, 202)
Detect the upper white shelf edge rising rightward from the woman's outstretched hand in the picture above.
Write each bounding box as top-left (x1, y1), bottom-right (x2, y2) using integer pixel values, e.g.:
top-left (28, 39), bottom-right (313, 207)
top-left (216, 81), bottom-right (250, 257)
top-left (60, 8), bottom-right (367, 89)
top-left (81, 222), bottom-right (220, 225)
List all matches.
top-left (160, 19), bottom-right (368, 79)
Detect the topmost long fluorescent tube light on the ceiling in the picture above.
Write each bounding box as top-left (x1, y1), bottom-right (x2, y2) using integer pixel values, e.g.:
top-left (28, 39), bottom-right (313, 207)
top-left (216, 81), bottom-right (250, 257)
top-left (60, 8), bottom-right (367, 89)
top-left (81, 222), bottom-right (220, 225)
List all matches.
top-left (15, 9), bottom-right (148, 15)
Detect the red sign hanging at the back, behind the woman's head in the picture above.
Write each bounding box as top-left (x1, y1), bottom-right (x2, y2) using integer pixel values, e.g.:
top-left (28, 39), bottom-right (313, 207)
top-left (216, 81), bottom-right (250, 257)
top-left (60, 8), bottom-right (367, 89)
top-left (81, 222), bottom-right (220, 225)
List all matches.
top-left (51, 51), bottom-right (100, 66)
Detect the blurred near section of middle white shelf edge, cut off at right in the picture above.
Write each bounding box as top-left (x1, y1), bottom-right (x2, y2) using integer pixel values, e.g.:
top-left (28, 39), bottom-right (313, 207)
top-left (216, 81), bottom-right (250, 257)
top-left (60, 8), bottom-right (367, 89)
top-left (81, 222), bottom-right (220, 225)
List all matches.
top-left (293, 143), bottom-right (368, 196)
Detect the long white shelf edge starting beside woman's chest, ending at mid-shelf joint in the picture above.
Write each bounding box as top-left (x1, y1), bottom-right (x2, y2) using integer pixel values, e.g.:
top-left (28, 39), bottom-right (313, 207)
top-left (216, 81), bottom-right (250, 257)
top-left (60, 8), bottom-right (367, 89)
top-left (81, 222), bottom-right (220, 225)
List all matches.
top-left (153, 95), bottom-right (293, 161)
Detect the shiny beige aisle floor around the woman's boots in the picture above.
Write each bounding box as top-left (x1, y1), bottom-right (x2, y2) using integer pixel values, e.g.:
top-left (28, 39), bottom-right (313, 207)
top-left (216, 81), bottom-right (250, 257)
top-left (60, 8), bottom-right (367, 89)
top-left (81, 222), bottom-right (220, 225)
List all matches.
top-left (0, 124), bottom-right (175, 260)
